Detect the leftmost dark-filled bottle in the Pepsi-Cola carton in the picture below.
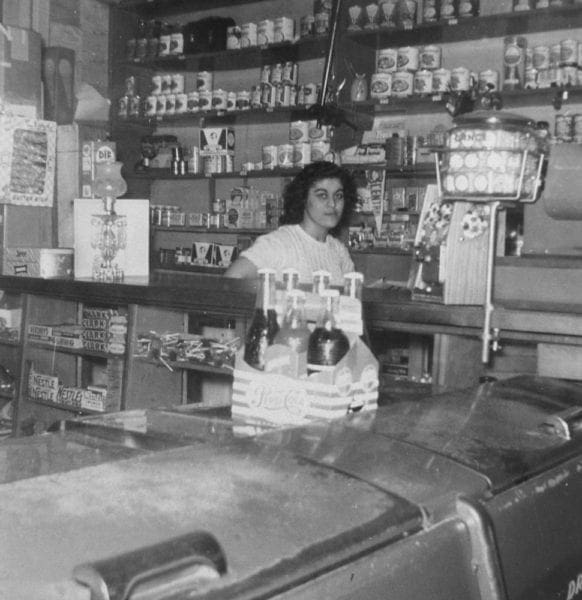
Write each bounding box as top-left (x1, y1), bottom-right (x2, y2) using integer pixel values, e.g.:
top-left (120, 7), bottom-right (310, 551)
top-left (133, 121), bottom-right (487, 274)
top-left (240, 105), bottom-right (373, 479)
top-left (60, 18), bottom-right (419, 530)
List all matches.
top-left (244, 269), bottom-right (279, 371)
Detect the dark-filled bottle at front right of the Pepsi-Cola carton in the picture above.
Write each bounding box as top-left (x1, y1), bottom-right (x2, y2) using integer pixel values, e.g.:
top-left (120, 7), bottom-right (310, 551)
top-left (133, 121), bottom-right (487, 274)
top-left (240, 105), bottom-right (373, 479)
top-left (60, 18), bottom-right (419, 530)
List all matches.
top-left (307, 289), bottom-right (350, 374)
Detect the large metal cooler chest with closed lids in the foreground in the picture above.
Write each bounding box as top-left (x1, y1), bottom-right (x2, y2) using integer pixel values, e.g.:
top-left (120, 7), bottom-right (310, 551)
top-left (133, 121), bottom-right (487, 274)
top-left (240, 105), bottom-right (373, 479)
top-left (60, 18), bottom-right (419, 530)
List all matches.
top-left (0, 377), bottom-right (582, 600)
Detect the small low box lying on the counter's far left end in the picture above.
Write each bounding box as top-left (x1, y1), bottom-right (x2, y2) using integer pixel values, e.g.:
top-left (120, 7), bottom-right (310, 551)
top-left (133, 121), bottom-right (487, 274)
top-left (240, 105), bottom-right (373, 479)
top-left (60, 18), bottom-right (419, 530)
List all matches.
top-left (0, 248), bottom-right (73, 279)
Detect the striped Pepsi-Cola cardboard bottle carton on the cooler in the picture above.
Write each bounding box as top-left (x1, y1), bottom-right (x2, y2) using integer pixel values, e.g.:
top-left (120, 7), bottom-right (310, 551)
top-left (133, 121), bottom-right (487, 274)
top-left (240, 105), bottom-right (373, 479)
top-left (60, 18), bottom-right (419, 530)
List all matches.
top-left (232, 337), bottom-right (379, 425)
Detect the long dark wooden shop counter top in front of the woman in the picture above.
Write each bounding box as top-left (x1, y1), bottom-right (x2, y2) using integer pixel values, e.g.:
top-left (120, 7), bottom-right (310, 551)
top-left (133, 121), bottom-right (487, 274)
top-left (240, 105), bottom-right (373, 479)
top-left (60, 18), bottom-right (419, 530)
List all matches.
top-left (0, 272), bottom-right (582, 344)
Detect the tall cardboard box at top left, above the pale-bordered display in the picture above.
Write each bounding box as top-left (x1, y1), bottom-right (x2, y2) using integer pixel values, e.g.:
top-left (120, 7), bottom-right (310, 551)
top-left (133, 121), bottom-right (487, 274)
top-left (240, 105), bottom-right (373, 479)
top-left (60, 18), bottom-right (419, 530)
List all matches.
top-left (0, 26), bottom-right (43, 119)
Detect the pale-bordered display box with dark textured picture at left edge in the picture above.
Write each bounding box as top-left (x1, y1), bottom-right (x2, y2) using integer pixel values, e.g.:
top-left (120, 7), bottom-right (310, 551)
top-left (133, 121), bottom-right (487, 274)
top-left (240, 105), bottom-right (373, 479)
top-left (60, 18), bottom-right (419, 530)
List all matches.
top-left (0, 115), bottom-right (57, 206)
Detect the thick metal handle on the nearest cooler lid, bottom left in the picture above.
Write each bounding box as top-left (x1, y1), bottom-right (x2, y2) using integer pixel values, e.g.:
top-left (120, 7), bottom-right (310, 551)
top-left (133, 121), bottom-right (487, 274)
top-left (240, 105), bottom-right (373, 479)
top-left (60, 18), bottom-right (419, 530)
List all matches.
top-left (73, 531), bottom-right (226, 600)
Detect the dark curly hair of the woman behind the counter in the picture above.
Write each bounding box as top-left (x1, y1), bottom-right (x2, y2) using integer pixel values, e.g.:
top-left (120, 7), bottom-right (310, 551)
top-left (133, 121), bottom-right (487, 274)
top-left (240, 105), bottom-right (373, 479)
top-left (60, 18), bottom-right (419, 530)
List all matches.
top-left (279, 161), bottom-right (357, 236)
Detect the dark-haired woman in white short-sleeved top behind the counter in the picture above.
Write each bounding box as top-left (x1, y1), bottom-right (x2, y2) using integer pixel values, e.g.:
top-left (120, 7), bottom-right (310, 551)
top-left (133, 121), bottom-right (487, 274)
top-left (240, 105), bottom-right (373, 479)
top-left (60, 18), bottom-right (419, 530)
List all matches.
top-left (225, 161), bottom-right (356, 285)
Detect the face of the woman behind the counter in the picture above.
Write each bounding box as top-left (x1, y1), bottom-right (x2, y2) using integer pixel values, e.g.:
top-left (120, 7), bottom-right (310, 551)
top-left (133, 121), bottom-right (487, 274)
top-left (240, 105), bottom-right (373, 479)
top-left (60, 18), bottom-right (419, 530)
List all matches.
top-left (303, 177), bottom-right (345, 237)
